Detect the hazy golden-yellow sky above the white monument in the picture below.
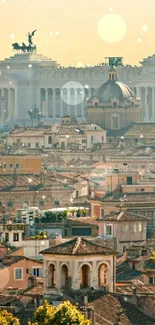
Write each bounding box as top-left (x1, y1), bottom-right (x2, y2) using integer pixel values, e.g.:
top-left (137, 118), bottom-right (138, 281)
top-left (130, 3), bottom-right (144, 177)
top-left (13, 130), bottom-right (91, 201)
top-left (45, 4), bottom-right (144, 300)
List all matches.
top-left (0, 0), bottom-right (155, 66)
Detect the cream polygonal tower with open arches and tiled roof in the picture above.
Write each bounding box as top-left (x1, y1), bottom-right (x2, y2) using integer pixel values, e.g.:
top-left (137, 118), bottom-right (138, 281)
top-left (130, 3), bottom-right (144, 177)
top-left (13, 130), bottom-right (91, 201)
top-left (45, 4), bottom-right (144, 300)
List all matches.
top-left (41, 238), bottom-right (116, 296)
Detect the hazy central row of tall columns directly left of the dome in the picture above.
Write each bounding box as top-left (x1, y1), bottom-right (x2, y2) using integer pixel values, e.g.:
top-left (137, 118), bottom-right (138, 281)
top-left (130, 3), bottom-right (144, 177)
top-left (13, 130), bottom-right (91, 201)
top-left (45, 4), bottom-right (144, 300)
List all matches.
top-left (40, 88), bottom-right (95, 119)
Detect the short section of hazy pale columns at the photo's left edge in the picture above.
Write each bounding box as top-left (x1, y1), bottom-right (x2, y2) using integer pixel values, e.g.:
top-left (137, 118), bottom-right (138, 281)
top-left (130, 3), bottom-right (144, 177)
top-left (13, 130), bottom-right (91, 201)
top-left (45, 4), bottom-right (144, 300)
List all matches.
top-left (0, 88), bottom-right (16, 122)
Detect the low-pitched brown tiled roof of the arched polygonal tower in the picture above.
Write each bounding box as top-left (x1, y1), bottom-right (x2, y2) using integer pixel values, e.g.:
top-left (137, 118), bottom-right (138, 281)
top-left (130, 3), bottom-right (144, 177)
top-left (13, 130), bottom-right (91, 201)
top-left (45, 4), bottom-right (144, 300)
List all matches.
top-left (40, 238), bottom-right (116, 255)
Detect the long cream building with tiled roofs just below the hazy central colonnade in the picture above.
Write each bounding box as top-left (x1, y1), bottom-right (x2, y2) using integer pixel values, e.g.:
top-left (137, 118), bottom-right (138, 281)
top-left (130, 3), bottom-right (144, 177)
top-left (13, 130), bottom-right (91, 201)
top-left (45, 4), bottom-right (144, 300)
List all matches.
top-left (6, 123), bottom-right (106, 149)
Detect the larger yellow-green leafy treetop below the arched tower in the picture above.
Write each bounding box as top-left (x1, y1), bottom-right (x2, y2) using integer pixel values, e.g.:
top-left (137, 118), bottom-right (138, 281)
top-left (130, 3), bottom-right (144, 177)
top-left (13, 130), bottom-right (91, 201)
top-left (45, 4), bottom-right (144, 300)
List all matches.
top-left (28, 301), bottom-right (90, 325)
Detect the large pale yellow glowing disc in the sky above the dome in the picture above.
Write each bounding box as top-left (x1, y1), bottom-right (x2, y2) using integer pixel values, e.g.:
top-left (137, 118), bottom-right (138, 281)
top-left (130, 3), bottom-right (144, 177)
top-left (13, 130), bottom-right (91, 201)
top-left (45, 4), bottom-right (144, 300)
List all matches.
top-left (98, 14), bottom-right (126, 43)
